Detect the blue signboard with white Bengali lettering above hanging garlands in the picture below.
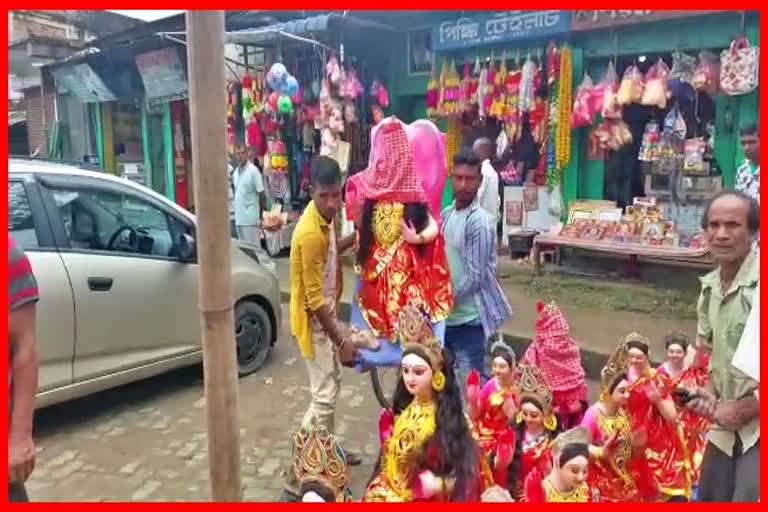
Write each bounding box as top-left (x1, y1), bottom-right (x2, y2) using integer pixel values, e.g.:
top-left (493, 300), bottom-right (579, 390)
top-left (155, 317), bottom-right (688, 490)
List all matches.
top-left (432, 10), bottom-right (571, 52)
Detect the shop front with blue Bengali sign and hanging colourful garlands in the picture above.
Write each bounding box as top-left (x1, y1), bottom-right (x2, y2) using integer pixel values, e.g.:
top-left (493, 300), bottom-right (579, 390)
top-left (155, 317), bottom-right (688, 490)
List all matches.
top-left (425, 10), bottom-right (581, 242)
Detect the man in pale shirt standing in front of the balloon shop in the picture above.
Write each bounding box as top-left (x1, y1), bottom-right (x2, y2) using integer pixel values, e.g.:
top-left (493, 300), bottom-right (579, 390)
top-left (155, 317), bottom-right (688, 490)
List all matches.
top-left (232, 145), bottom-right (267, 245)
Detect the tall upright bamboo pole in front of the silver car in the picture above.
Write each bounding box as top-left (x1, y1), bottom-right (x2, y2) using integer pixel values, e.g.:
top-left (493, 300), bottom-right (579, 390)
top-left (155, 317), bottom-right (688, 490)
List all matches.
top-left (186, 11), bottom-right (242, 501)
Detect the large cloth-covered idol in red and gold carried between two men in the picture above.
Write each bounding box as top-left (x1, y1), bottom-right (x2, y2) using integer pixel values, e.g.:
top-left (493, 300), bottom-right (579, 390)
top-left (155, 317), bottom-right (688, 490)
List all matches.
top-left (346, 117), bottom-right (453, 367)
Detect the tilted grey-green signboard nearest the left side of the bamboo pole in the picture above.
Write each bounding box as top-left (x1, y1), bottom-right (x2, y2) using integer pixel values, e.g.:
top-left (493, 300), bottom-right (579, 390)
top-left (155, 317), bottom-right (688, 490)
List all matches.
top-left (136, 47), bottom-right (189, 104)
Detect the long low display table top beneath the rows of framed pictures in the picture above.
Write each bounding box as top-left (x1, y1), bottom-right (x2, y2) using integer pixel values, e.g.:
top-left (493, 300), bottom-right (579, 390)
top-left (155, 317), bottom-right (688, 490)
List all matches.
top-left (532, 233), bottom-right (712, 275)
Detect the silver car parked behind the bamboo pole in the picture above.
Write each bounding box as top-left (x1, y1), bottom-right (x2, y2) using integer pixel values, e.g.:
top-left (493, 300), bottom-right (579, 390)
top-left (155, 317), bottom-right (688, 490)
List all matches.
top-left (8, 158), bottom-right (281, 407)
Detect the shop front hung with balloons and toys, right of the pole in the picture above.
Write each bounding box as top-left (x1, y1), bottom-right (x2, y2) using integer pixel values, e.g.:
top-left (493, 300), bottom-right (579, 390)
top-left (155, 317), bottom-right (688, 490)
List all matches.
top-left (222, 14), bottom-right (400, 254)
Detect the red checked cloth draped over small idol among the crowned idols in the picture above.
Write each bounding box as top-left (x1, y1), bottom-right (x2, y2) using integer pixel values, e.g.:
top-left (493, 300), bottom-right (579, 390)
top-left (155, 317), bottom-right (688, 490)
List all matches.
top-left (521, 302), bottom-right (587, 409)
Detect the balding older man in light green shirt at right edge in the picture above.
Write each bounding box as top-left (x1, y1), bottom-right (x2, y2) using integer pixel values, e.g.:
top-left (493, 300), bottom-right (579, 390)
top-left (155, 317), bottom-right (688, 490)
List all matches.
top-left (690, 190), bottom-right (760, 502)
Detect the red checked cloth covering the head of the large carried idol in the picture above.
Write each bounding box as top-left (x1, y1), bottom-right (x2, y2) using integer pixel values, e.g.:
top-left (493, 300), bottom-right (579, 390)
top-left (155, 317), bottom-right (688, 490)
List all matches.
top-left (350, 118), bottom-right (427, 203)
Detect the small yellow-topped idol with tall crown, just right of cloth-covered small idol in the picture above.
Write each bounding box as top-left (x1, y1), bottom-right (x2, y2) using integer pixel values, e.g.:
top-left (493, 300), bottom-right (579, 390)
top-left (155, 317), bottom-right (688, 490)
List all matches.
top-left (581, 343), bottom-right (658, 502)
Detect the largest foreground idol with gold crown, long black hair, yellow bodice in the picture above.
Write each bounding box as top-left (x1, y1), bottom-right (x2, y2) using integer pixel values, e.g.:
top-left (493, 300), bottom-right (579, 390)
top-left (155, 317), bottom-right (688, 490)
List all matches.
top-left (363, 302), bottom-right (493, 502)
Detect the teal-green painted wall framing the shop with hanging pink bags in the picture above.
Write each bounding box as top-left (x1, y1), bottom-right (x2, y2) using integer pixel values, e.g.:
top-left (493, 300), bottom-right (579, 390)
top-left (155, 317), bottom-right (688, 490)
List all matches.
top-left (573, 11), bottom-right (760, 199)
